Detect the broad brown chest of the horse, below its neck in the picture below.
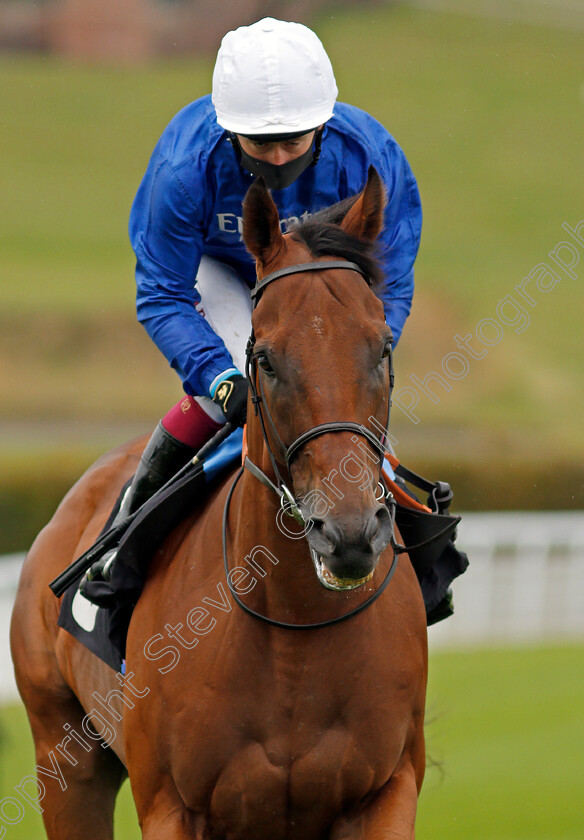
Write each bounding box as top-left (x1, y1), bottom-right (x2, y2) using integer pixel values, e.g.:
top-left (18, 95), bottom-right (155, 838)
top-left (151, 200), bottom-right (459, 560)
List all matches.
top-left (138, 564), bottom-right (424, 840)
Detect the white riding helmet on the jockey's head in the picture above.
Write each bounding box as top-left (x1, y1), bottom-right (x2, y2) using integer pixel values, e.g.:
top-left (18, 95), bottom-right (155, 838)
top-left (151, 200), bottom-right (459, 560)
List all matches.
top-left (211, 18), bottom-right (338, 136)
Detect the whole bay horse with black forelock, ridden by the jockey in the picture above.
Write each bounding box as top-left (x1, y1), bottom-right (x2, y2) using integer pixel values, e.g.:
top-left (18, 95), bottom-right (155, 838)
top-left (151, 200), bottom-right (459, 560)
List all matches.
top-left (11, 170), bottom-right (427, 840)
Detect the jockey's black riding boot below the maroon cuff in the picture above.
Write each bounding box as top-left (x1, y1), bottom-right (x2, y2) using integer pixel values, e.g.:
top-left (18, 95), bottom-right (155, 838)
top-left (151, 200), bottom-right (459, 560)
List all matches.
top-left (79, 423), bottom-right (195, 602)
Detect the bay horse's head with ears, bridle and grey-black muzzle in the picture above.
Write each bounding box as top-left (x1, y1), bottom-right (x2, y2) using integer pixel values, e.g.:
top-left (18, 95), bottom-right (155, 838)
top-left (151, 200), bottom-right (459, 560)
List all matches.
top-left (243, 168), bottom-right (392, 589)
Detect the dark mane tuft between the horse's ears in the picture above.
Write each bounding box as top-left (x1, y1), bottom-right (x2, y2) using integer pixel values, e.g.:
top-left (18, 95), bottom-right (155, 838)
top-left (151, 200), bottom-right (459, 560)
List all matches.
top-left (289, 195), bottom-right (384, 289)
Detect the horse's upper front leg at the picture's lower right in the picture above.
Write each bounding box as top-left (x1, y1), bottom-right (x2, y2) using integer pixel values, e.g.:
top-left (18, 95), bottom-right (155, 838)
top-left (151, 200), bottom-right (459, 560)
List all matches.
top-left (330, 749), bottom-right (425, 840)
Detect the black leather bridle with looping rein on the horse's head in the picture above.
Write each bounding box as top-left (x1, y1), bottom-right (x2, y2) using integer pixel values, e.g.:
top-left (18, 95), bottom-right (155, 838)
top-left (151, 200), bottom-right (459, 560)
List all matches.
top-left (223, 260), bottom-right (399, 630)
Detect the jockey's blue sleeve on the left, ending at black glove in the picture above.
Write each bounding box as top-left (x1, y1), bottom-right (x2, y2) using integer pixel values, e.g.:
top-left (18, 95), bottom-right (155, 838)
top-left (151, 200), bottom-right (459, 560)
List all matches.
top-left (130, 161), bottom-right (233, 396)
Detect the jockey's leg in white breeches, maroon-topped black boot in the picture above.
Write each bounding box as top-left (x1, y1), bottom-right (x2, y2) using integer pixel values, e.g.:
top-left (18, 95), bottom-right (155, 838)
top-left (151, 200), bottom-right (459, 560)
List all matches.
top-left (80, 257), bottom-right (251, 600)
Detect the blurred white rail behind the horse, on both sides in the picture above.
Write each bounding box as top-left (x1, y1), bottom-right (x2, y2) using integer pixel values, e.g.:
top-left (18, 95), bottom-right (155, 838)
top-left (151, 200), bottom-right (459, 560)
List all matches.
top-left (0, 512), bottom-right (584, 702)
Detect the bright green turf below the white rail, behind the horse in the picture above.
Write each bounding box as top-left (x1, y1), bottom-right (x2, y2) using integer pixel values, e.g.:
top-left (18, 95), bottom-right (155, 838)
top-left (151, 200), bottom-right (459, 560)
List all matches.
top-left (0, 644), bottom-right (584, 840)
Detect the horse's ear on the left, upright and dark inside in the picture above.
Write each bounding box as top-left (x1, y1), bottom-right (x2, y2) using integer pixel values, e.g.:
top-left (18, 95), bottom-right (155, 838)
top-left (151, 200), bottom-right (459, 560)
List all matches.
top-left (243, 176), bottom-right (284, 265)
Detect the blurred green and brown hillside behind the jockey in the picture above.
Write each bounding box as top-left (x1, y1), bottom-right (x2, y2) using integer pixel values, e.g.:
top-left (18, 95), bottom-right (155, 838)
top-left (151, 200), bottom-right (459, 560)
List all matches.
top-left (0, 4), bottom-right (584, 551)
